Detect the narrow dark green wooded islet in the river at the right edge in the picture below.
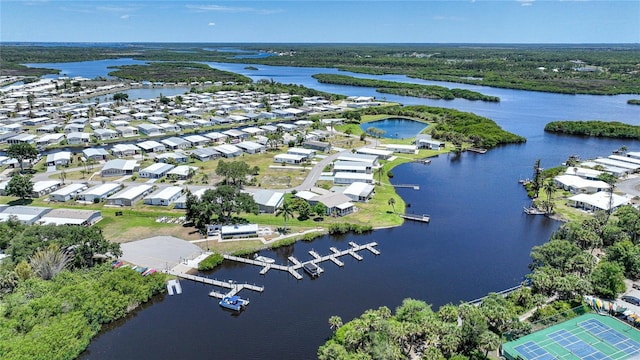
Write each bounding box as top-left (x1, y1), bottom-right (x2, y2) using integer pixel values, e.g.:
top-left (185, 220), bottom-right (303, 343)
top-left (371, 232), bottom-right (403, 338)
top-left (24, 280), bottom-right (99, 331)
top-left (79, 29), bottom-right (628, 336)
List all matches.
top-left (544, 120), bottom-right (640, 139)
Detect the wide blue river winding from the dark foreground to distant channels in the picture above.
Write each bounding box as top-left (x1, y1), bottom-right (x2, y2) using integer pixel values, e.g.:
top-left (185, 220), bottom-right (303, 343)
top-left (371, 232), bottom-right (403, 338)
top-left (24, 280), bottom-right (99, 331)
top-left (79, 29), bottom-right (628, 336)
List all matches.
top-left (26, 57), bottom-right (640, 359)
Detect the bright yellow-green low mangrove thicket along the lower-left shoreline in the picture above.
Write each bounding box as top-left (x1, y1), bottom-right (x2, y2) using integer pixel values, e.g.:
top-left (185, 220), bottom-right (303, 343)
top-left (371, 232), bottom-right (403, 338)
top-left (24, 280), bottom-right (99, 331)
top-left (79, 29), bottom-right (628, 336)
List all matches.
top-left (0, 265), bottom-right (165, 360)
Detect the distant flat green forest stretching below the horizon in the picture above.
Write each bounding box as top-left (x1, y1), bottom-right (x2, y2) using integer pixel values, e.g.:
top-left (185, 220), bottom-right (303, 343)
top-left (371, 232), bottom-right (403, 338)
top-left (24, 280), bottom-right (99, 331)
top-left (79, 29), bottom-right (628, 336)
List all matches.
top-left (5, 43), bottom-right (640, 94)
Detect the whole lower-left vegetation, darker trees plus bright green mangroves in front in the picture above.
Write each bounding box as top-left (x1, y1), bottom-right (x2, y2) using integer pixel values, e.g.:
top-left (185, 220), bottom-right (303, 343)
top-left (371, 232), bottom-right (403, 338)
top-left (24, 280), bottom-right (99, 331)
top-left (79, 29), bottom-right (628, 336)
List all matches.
top-left (0, 219), bottom-right (164, 359)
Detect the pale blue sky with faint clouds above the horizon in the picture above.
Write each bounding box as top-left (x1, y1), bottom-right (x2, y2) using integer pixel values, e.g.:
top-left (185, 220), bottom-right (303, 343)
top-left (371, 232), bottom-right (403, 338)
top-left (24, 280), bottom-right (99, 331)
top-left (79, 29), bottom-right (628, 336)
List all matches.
top-left (0, 0), bottom-right (640, 43)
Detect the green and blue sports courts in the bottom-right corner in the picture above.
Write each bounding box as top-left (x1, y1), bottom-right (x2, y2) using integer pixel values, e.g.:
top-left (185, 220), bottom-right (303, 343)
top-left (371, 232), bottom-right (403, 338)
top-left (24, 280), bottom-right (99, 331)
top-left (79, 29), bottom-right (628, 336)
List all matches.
top-left (502, 314), bottom-right (640, 360)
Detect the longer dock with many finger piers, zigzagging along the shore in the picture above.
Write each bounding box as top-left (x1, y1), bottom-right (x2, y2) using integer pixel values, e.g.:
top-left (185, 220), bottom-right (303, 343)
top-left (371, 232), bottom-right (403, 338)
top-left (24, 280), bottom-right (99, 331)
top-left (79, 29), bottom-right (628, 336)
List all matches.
top-left (223, 242), bottom-right (380, 280)
